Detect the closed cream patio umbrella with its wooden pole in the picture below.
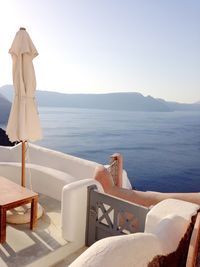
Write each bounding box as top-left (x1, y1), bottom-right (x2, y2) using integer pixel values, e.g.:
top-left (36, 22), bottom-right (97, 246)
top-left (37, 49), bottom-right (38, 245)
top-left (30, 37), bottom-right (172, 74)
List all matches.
top-left (6, 28), bottom-right (42, 186)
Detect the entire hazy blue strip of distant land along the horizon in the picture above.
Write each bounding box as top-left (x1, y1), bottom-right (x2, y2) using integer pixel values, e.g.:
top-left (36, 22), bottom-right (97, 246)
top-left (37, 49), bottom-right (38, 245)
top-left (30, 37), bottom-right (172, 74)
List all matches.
top-left (0, 85), bottom-right (200, 123)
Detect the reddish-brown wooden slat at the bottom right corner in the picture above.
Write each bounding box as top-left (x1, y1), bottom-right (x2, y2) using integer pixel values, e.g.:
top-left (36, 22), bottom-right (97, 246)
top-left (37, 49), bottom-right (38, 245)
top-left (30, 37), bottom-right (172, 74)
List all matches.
top-left (186, 213), bottom-right (200, 267)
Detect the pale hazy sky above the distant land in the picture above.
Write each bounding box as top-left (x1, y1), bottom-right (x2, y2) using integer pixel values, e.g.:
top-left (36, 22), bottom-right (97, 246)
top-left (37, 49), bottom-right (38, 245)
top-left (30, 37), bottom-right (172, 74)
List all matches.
top-left (0, 0), bottom-right (200, 103)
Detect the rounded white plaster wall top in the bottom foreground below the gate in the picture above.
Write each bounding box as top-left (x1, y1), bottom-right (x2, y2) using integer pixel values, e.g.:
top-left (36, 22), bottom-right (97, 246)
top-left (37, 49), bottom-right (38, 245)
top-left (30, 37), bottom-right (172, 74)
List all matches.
top-left (70, 233), bottom-right (162, 267)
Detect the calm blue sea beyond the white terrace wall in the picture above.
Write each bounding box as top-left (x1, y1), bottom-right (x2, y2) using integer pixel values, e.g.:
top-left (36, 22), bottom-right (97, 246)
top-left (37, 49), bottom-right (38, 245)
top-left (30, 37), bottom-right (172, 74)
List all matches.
top-left (0, 107), bottom-right (200, 192)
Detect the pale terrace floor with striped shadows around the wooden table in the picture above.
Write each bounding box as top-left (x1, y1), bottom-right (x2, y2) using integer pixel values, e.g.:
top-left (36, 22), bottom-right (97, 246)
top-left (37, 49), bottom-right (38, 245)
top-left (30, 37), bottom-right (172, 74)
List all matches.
top-left (0, 195), bottom-right (85, 267)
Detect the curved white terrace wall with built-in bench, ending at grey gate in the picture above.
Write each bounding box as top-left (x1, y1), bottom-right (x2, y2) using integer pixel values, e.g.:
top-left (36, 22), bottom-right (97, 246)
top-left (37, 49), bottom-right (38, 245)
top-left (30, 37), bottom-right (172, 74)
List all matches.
top-left (0, 143), bottom-right (130, 245)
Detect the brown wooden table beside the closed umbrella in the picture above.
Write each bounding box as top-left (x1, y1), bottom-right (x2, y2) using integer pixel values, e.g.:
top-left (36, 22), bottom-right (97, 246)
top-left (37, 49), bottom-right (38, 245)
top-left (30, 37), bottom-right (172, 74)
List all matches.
top-left (0, 176), bottom-right (38, 243)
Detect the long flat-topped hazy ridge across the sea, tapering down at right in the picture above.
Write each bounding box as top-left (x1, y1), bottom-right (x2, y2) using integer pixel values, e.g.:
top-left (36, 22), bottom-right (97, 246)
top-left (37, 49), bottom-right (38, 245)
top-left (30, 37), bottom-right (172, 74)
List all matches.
top-left (0, 85), bottom-right (170, 111)
